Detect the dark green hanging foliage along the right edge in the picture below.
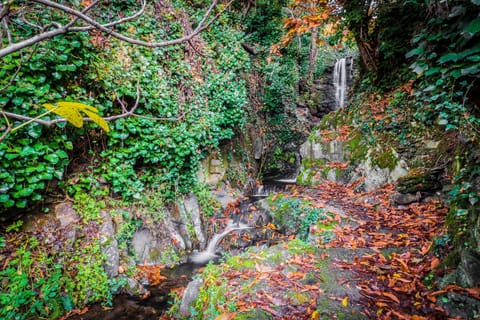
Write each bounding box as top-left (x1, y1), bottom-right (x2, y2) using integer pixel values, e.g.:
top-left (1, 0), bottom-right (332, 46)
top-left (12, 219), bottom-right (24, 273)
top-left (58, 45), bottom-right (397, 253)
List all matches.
top-left (407, 1), bottom-right (480, 255)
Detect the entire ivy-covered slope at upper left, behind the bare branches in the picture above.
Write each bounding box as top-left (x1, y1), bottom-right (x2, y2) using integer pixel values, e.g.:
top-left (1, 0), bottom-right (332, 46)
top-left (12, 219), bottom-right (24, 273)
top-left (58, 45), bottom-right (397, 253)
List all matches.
top-left (0, 1), bottom-right (249, 212)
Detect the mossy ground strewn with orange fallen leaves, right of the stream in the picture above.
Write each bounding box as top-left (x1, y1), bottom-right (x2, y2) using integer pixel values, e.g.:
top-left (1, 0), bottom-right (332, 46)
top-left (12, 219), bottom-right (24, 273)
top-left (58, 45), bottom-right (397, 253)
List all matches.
top-left (167, 182), bottom-right (478, 319)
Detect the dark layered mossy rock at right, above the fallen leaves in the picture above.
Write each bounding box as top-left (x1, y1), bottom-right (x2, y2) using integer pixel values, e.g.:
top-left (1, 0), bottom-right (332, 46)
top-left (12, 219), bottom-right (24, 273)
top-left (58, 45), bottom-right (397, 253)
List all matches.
top-left (397, 169), bottom-right (443, 193)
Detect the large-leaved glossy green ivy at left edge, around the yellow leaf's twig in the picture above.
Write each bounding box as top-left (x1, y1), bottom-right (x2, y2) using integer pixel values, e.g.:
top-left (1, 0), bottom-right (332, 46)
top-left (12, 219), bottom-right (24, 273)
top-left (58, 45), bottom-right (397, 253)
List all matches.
top-left (0, 30), bottom-right (95, 212)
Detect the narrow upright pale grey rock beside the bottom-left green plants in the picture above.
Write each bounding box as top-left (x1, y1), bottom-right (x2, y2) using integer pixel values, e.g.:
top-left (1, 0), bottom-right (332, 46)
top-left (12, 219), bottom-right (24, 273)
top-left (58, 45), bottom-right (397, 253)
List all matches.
top-left (100, 211), bottom-right (120, 278)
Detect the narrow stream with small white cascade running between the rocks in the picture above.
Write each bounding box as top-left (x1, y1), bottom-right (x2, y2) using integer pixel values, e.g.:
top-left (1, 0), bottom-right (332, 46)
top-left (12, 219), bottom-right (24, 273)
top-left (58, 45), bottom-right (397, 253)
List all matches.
top-left (67, 180), bottom-right (290, 320)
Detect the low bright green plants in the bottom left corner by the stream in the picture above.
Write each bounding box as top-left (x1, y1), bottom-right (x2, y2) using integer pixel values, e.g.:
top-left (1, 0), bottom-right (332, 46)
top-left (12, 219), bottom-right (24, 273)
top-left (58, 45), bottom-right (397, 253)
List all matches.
top-left (0, 231), bottom-right (115, 319)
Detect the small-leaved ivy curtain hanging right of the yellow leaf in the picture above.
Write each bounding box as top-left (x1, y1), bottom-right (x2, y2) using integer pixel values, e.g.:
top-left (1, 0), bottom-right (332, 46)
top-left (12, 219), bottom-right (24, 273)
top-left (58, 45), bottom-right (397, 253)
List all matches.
top-left (97, 5), bottom-right (247, 199)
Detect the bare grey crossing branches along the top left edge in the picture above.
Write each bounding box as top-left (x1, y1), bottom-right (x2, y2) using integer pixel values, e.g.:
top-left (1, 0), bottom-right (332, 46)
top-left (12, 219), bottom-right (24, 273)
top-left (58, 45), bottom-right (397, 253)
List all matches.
top-left (0, 0), bottom-right (223, 58)
